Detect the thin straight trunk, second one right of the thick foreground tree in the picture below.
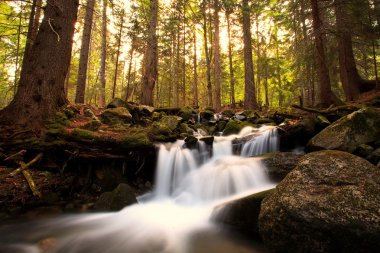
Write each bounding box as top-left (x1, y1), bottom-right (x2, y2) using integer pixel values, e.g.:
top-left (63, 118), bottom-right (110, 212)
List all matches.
top-left (99, 0), bottom-right (108, 107)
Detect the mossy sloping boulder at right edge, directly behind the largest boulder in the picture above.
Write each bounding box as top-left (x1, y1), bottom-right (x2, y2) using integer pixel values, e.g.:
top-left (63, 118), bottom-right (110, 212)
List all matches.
top-left (307, 109), bottom-right (380, 153)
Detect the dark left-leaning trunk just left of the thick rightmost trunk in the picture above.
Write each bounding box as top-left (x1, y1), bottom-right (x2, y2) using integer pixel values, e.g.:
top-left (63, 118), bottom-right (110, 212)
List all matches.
top-left (310, 0), bottom-right (339, 106)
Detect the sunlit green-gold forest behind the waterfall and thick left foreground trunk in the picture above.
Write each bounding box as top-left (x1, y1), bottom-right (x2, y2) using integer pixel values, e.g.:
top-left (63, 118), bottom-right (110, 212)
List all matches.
top-left (0, 0), bottom-right (380, 119)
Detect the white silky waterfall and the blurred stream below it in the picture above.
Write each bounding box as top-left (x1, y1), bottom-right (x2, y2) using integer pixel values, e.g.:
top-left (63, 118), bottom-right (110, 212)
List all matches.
top-left (0, 127), bottom-right (278, 253)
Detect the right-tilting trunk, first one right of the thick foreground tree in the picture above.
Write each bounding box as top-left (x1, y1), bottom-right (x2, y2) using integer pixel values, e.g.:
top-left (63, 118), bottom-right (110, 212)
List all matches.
top-left (75, 0), bottom-right (95, 104)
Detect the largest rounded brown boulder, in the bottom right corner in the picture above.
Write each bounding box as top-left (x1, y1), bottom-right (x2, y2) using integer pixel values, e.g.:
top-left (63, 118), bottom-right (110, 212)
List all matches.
top-left (259, 150), bottom-right (380, 252)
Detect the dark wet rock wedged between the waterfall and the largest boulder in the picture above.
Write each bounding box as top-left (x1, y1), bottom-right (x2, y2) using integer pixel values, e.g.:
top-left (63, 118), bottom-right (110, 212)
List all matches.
top-left (259, 152), bottom-right (303, 182)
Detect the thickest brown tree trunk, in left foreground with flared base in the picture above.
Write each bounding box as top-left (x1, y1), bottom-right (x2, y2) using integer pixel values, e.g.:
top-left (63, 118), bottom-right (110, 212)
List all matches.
top-left (0, 0), bottom-right (78, 133)
